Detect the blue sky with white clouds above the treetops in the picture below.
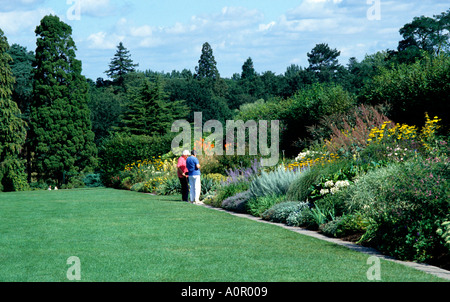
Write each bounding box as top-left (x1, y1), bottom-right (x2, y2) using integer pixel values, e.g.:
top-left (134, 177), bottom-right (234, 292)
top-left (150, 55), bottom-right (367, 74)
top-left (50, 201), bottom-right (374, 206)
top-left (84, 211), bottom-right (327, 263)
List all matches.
top-left (0, 0), bottom-right (450, 80)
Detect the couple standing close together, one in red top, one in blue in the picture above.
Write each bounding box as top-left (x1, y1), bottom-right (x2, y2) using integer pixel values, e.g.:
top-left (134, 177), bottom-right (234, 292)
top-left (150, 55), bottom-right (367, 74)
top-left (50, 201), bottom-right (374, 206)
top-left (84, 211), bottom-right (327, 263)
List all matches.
top-left (177, 150), bottom-right (201, 203)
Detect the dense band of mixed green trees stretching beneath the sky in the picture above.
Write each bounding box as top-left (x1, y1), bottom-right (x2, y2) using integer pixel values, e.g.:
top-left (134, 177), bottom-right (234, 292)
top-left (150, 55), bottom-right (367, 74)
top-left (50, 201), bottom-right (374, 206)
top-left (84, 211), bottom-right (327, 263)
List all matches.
top-left (0, 10), bottom-right (450, 191)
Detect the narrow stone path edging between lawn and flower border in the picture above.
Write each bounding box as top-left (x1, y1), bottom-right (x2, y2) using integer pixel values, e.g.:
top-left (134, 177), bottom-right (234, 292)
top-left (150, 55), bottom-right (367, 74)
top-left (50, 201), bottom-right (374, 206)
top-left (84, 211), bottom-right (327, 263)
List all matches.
top-left (197, 203), bottom-right (450, 280)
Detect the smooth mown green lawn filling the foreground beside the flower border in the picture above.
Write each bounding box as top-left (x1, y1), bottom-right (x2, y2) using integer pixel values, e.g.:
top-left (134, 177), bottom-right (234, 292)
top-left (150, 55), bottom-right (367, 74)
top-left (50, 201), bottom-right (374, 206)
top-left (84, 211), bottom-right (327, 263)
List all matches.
top-left (0, 189), bottom-right (443, 282)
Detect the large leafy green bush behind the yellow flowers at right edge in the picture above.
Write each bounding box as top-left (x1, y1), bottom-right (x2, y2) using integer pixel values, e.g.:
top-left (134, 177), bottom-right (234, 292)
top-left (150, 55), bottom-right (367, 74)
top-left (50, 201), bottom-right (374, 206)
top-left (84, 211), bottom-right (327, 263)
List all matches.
top-left (361, 54), bottom-right (450, 129)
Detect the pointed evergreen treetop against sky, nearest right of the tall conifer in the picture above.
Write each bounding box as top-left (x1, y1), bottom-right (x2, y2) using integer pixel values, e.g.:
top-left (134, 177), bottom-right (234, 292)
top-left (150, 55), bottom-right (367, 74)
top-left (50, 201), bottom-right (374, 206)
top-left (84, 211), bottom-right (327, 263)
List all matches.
top-left (105, 42), bottom-right (139, 85)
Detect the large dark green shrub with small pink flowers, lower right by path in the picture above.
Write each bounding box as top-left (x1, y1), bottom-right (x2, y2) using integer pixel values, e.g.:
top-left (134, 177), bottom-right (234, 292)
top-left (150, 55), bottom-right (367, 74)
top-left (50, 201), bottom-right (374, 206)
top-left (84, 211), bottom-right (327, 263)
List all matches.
top-left (350, 157), bottom-right (450, 262)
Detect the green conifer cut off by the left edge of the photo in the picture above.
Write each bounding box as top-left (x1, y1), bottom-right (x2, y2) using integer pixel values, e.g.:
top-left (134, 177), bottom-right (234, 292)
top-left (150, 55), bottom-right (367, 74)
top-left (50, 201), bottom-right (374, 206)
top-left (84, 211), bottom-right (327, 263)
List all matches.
top-left (0, 29), bottom-right (27, 191)
